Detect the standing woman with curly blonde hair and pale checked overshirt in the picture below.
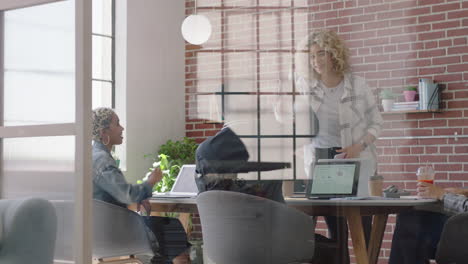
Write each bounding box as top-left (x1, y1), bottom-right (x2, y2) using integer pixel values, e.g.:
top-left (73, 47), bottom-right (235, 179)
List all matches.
top-left (295, 30), bottom-right (383, 264)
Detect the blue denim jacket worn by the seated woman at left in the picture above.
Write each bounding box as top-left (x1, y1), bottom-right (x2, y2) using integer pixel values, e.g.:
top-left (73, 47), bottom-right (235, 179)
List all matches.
top-left (93, 142), bottom-right (152, 208)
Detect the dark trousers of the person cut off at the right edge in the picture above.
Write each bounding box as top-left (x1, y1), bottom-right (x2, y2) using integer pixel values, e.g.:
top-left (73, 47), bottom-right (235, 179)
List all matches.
top-left (388, 211), bottom-right (448, 264)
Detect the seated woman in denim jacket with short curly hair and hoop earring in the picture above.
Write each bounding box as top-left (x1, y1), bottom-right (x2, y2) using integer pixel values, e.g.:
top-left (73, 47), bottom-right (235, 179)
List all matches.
top-left (92, 107), bottom-right (189, 263)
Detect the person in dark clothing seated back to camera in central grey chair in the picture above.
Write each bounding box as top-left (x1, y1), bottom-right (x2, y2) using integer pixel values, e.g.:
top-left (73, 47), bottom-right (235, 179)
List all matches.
top-left (195, 127), bottom-right (291, 202)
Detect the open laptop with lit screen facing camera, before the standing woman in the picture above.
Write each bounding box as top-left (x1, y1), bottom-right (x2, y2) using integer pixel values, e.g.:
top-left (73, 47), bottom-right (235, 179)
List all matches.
top-left (306, 160), bottom-right (359, 199)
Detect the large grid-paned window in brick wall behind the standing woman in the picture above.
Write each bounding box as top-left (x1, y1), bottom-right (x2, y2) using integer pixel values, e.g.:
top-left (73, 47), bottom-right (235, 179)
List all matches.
top-left (187, 0), bottom-right (313, 179)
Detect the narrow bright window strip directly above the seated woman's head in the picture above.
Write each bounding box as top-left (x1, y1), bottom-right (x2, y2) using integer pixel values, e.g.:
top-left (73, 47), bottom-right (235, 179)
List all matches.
top-left (92, 0), bottom-right (115, 108)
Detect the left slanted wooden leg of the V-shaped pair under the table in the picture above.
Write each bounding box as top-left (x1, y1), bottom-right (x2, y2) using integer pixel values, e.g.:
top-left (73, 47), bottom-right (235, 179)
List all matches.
top-left (345, 207), bottom-right (369, 264)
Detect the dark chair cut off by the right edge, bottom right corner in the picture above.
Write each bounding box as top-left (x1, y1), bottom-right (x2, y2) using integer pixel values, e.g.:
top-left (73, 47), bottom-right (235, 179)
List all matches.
top-left (436, 213), bottom-right (468, 264)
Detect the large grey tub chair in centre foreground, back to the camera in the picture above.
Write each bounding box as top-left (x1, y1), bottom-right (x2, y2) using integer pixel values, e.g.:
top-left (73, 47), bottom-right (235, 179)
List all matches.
top-left (197, 191), bottom-right (315, 264)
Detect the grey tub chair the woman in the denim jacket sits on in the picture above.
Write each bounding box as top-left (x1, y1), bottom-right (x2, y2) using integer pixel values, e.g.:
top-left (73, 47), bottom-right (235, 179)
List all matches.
top-left (54, 200), bottom-right (153, 264)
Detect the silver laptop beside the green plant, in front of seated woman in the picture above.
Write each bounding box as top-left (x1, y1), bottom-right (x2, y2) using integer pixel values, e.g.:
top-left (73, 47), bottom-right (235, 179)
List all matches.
top-left (153, 164), bottom-right (198, 198)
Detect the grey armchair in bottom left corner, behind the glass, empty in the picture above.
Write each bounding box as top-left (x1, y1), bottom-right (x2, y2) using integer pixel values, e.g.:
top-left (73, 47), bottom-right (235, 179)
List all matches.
top-left (0, 198), bottom-right (57, 264)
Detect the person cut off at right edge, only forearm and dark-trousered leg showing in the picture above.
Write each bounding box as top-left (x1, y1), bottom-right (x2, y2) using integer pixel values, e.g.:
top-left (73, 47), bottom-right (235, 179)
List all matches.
top-left (389, 182), bottom-right (468, 264)
